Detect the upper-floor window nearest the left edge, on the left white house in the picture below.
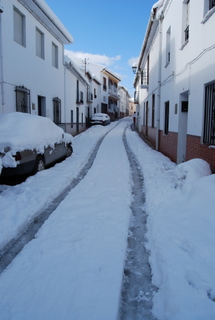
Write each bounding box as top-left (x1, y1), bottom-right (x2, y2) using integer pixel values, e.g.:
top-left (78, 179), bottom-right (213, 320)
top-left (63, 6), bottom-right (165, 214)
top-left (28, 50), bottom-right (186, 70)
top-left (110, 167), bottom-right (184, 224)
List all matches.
top-left (13, 7), bottom-right (26, 47)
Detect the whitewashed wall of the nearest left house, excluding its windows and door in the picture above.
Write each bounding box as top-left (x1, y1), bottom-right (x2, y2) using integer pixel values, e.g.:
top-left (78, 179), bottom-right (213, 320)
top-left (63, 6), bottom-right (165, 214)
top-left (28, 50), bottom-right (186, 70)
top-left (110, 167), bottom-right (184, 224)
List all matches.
top-left (1, 0), bottom-right (67, 119)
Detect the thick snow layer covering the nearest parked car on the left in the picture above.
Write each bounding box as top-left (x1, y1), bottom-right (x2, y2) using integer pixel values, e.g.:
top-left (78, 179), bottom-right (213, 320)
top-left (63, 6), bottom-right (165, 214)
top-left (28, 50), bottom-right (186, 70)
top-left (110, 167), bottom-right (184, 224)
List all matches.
top-left (0, 112), bottom-right (72, 153)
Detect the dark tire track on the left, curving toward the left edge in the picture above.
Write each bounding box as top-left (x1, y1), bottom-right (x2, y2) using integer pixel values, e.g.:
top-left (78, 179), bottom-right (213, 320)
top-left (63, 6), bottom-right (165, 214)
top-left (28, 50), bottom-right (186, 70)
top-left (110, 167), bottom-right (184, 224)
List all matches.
top-left (0, 122), bottom-right (119, 274)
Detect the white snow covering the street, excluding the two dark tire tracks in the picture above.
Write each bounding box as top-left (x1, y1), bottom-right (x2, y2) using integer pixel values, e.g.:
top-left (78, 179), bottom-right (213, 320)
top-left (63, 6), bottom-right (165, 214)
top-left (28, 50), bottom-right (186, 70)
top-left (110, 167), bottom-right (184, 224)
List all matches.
top-left (0, 118), bottom-right (215, 320)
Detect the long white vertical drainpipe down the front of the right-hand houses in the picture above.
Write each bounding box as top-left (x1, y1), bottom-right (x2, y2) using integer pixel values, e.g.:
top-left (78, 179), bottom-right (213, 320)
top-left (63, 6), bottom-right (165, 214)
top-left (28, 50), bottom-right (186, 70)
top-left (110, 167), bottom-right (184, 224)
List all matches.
top-left (156, 12), bottom-right (164, 151)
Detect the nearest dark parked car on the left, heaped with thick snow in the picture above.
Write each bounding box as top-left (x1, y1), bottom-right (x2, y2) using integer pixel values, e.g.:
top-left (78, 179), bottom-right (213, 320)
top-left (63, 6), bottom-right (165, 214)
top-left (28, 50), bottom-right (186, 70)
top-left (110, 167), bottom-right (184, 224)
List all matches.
top-left (0, 112), bottom-right (73, 177)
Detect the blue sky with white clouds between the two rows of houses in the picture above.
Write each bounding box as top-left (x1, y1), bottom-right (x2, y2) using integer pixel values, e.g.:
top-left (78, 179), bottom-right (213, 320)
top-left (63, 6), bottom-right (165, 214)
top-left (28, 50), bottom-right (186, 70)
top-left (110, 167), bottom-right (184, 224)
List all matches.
top-left (45, 0), bottom-right (156, 96)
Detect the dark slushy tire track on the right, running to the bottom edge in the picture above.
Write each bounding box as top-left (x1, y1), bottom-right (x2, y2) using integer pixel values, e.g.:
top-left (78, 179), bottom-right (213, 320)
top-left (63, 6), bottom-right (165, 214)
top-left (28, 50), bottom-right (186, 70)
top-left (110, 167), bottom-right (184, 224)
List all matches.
top-left (119, 128), bottom-right (156, 320)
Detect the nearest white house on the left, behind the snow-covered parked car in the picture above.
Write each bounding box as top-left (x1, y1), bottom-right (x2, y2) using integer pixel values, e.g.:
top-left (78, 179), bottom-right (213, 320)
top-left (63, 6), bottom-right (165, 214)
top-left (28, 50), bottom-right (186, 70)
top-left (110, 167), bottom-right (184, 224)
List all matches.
top-left (0, 0), bottom-right (73, 123)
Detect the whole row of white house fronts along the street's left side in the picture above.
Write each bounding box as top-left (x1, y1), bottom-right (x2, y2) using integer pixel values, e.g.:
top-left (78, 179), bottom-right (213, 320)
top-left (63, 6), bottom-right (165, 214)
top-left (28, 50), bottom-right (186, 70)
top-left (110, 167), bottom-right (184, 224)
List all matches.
top-left (0, 0), bottom-right (127, 135)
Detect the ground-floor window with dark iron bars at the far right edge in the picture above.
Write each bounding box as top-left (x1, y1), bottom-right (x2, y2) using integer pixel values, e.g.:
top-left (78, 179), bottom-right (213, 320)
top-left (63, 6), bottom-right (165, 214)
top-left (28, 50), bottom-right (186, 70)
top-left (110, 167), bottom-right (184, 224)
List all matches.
top-left (203, 82), bottom-right (215, 145)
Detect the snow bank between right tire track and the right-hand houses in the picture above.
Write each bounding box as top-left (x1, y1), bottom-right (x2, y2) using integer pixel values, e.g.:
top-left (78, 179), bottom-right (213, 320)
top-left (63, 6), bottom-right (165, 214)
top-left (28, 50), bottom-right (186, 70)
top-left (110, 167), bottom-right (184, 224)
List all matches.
top-left (128, 127), bottom-right (215, 320)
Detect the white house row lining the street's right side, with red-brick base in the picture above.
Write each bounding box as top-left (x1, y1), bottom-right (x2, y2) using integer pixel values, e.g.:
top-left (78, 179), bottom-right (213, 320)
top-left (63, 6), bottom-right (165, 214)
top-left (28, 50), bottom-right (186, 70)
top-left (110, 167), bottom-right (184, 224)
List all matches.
top-left (134, 0), bottom-right (215, 171)
